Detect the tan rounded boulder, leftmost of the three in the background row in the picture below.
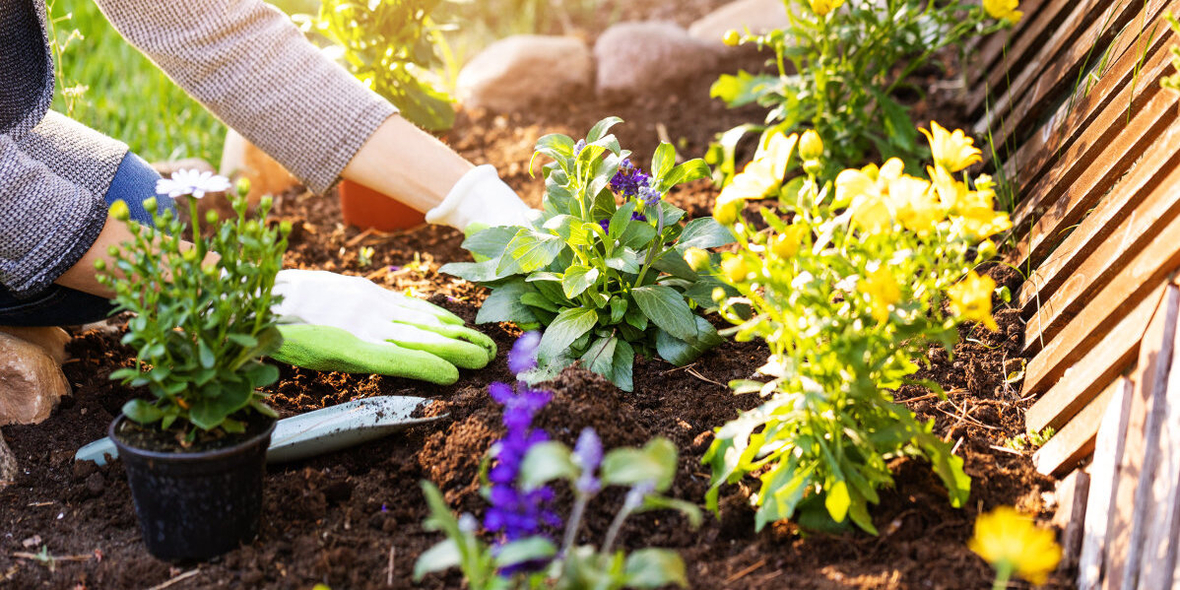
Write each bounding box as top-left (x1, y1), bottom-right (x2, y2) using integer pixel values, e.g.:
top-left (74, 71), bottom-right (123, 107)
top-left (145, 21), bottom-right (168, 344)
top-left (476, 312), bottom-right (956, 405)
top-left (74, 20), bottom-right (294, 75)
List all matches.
top-left (455, 35), bottom-right (594, 112)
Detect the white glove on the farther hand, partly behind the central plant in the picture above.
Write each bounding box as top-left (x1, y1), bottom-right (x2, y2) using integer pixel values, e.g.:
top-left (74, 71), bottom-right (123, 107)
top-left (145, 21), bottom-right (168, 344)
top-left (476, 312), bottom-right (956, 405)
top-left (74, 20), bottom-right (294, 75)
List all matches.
top-left (426, 164), bottom-right (540, 231)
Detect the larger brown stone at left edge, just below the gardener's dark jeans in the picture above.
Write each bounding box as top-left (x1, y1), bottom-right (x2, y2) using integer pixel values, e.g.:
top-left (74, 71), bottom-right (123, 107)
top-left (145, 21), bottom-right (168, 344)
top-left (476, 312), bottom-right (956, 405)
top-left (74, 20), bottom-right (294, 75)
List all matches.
top-left (0, 334), bottom-right (70, 426)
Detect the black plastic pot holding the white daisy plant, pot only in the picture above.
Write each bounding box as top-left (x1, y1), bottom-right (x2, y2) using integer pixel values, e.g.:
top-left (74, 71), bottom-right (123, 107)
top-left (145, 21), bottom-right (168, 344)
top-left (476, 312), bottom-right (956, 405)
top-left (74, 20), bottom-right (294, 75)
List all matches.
top-left (109, 414), bottom-right (275, 562)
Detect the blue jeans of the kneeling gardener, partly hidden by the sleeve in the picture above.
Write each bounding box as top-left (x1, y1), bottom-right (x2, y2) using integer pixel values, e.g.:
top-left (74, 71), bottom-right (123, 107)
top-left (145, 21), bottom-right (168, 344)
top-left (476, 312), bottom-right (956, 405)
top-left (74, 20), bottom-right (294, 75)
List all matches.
top-left (0, 153), bottom-right (176, 326)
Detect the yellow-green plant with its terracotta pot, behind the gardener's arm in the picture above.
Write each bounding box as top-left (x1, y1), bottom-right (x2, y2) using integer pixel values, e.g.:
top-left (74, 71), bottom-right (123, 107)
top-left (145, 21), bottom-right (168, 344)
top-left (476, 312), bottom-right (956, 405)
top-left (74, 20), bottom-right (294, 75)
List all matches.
top-left (293, 0), bottom-right (454, 231)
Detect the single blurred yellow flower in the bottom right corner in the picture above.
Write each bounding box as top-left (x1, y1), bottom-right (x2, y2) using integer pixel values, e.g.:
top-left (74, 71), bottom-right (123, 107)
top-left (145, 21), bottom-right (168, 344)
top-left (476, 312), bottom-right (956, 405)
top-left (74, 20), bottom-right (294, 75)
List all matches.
top-left (966, 506), bottom-right (1061, 585)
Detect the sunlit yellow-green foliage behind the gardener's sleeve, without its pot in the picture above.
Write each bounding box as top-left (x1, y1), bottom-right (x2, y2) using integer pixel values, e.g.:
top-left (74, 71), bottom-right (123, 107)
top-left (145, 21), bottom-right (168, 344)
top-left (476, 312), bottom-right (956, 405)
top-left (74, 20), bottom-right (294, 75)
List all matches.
top-left (291, 0), bottom-right (454, 131)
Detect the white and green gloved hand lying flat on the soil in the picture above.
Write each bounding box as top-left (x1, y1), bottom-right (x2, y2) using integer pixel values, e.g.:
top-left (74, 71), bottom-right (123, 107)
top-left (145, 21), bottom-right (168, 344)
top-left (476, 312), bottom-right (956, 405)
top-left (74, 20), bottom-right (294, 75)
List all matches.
top-left (271, 270), bottom-right (496, 385)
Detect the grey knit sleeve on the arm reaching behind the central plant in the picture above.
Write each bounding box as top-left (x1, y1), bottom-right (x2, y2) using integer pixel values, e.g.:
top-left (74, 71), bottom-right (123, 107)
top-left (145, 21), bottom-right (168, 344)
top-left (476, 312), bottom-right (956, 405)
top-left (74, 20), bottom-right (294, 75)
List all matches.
top-left (96, 0), bottom-right (396, 192)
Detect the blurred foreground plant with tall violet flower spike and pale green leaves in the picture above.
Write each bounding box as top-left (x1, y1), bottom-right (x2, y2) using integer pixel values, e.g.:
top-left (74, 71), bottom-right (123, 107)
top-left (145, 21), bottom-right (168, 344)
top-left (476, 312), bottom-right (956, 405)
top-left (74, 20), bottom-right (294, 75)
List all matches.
top-left (414, 333), bottom-right (701, 590)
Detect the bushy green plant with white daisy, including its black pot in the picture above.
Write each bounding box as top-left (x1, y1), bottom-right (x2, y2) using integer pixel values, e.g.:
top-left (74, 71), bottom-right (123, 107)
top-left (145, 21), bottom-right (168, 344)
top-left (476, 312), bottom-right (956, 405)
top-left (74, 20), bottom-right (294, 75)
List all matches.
top-left (97, 171), bottom-right (290, 561)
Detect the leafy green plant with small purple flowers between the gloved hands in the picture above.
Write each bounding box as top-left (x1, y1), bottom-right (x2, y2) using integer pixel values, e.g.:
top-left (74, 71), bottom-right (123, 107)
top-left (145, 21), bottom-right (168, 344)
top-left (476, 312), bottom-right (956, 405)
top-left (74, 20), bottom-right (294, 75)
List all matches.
top-left (443, 117), bottom-right (734, 391)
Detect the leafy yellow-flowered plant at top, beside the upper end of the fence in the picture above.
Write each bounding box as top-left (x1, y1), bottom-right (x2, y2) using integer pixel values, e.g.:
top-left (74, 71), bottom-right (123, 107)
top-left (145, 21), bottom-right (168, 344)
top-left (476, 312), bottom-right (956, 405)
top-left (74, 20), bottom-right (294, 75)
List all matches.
top-left (707, 0), bottom-right (1020, 184)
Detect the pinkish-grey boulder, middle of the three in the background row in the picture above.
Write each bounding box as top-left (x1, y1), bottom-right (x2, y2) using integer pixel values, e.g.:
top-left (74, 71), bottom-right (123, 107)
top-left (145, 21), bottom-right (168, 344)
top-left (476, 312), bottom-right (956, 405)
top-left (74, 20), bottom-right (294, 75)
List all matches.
top-left (594, 21), bottom-right (725, 97)
